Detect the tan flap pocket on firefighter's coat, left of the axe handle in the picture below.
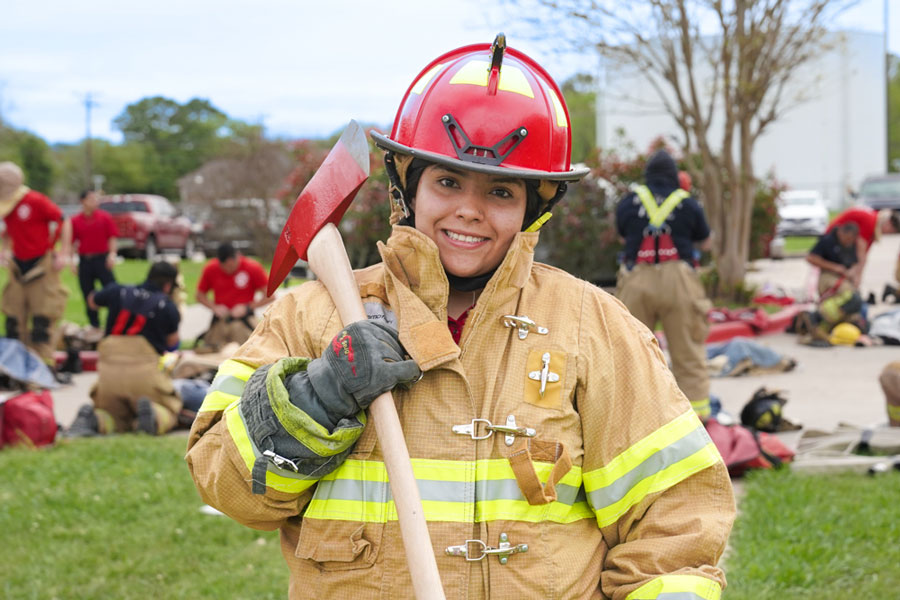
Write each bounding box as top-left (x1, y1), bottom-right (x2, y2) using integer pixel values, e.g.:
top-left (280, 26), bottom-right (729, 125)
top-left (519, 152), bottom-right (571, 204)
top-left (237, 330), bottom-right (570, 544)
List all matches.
top-left (294, 518), bottom-right (384, 571)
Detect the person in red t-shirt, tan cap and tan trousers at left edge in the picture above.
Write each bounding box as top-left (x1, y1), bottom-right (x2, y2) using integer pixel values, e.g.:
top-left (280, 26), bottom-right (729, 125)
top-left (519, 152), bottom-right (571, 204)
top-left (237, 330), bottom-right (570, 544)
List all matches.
top-left (0, 162), bottom-right (70, 366)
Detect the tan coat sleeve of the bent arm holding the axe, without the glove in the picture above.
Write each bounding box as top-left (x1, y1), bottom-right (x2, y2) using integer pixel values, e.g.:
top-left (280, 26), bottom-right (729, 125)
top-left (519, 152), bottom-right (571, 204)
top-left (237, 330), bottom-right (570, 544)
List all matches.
top-left (185, 284), bottom-right (334, 530)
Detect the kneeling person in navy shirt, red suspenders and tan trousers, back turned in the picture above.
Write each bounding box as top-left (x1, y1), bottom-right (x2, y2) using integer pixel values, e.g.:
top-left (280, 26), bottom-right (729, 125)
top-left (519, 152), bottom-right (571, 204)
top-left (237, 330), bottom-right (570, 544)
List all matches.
top-left (66, 261), bottom-right (181, 437)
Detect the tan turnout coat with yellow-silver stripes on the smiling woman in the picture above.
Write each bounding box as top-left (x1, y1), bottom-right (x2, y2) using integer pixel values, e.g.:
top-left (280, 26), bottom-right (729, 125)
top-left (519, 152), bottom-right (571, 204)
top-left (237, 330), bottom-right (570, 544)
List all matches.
top-left (187, 226), bottom-right (735, 600)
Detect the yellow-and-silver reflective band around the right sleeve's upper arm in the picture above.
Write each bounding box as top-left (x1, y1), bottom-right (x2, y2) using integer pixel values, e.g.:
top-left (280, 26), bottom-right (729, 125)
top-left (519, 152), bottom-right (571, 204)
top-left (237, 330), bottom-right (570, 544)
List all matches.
top-left (584, 410), bottom-right (721, 527)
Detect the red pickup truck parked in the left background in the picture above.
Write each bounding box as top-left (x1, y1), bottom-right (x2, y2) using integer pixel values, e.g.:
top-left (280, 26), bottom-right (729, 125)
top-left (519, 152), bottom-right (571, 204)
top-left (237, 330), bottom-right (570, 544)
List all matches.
top-left (100, 194), bottom-right (194, 260)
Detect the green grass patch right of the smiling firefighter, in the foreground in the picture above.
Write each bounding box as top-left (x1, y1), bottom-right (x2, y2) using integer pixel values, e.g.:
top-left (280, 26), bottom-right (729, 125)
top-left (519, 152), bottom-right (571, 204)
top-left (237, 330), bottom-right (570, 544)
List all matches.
top-left (723, 470), bottom-right (900, 600)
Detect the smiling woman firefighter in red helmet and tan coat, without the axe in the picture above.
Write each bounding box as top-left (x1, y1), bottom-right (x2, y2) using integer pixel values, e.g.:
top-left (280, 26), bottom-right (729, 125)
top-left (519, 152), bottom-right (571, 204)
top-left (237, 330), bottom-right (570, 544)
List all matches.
top-left (187, 36), bottom-right (734, 600)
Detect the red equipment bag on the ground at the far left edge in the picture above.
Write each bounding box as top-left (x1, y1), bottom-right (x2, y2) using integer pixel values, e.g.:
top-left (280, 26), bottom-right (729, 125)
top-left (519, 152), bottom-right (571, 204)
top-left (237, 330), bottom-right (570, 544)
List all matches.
top-left (0, 390), bottom-right (58, 447)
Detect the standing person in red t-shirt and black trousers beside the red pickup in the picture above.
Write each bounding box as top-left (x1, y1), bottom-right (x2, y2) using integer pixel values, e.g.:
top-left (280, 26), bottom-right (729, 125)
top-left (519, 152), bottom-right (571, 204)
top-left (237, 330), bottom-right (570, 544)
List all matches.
top-left (67, 190), bottom-right (119, 329)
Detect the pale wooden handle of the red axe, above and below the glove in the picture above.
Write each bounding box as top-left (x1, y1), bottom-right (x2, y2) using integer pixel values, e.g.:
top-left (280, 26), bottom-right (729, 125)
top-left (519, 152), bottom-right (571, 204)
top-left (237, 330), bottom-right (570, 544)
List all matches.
top-left (307, 223), bottom-right (444, 600)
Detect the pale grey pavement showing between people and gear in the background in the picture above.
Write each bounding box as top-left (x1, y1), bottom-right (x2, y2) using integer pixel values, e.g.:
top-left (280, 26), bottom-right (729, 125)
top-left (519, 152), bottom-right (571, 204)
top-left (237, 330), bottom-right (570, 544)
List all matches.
top-left (54, 235), bottom-right (900, 430)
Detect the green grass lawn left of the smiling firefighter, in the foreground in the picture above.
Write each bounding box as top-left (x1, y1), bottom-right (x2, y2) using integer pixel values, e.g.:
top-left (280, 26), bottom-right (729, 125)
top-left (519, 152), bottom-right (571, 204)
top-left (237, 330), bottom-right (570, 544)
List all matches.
top-left (0, 435), bottom-right (288, 600)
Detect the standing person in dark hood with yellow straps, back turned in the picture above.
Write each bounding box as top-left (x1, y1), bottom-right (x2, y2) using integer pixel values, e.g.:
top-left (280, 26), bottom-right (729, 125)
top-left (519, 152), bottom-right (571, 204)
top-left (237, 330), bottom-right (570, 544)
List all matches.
top-left (616, 150), bottom-right (712, 421)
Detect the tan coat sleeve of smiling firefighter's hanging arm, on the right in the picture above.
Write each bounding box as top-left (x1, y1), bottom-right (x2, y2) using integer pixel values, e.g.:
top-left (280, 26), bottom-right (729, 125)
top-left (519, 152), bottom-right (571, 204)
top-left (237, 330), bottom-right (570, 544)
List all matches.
top-left (576, 291), bottom-right (735, 600)
